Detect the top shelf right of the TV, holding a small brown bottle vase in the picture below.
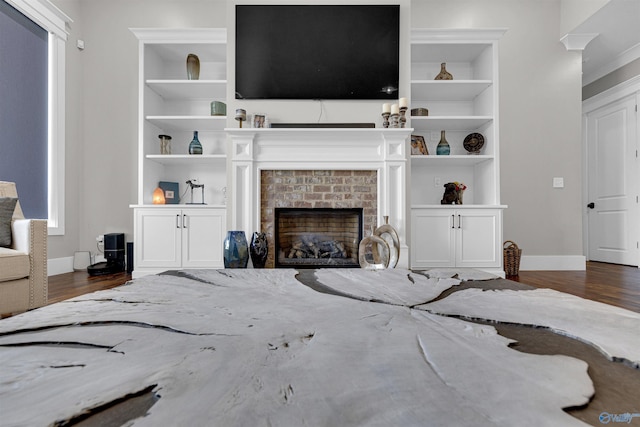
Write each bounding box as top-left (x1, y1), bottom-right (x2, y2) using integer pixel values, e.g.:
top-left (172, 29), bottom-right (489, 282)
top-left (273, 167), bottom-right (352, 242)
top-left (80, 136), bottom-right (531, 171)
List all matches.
top-left (411, 80), bottom-right (492, 102)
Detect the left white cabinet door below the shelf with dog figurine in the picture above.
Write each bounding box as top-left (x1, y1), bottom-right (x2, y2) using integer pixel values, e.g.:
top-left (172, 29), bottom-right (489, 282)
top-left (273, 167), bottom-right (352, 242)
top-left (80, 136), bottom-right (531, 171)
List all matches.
top-left (411, 209), bottom-right (455, 268)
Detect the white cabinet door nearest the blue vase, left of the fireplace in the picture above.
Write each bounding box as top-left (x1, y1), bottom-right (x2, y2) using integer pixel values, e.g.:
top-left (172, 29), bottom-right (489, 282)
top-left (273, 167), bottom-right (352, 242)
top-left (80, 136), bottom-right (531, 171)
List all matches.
top-left (182, 209), bottom-right (226, 268)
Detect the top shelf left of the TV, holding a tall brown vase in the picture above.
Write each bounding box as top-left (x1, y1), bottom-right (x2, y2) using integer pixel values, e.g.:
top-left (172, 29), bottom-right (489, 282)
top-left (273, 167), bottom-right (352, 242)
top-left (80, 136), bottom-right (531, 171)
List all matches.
top-left (146, 80), bottom-right (227, 101)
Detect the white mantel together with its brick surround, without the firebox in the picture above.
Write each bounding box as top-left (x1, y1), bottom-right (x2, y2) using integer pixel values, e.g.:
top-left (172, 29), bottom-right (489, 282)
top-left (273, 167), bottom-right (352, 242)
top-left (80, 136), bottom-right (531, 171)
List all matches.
top-left (226, 128), bottom-right (411, 268)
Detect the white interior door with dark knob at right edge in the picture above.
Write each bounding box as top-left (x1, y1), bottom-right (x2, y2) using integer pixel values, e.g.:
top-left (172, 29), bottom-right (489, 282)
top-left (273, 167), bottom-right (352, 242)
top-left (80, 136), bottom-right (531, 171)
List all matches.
top-left (586, 94), bottom-right (640, 266)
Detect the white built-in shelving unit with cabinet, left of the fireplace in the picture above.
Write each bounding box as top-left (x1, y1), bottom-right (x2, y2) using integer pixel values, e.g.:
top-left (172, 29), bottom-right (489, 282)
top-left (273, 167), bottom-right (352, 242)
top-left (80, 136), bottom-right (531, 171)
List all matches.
top-left (131, 28), bottom-right (227, 276)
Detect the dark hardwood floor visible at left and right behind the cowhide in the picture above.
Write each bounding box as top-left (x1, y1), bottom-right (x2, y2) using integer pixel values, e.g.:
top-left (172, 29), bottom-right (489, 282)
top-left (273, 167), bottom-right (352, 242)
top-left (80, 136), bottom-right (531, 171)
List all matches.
top-left (41, 262), bottom-right (640, 313)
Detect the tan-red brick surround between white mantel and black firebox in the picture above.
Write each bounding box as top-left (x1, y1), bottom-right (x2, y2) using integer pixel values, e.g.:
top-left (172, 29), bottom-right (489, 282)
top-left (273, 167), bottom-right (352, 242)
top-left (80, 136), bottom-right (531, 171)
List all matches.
top-left (260, 170), bottom-right (378, 267)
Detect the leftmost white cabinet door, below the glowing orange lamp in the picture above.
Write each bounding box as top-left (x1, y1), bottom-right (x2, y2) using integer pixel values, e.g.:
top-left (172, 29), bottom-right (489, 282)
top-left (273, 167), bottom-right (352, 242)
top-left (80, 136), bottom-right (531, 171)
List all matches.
top-left (134, 209), bottom-right (182, 268)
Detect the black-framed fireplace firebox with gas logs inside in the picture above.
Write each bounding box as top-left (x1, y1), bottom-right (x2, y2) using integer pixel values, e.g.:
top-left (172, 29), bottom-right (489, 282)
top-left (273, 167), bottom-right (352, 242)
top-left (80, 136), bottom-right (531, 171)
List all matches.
top-left (274, 208), bottom-right (363, 268)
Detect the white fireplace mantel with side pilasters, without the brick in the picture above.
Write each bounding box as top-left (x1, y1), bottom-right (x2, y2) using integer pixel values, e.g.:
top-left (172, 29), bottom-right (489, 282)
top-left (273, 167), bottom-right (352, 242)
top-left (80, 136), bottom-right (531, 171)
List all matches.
top-left (225, 128), bottom-right (413, 268)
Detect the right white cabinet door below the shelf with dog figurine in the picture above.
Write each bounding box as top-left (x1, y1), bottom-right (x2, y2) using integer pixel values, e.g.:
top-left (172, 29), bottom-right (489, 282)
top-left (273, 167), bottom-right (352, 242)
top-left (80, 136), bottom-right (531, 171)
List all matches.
top-left (455, 209), bottom-right (502, 268)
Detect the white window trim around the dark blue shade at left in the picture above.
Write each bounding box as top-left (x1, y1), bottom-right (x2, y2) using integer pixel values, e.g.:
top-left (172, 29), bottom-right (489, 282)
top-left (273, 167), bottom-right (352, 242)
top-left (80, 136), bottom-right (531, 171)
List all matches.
top-left (0, 0), bottom-right (71, 235)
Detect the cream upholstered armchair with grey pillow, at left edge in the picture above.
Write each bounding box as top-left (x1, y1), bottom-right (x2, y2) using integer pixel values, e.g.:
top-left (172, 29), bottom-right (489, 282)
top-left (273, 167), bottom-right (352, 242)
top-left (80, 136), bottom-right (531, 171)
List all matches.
top-left (0, 181), bottom-right (48, 315)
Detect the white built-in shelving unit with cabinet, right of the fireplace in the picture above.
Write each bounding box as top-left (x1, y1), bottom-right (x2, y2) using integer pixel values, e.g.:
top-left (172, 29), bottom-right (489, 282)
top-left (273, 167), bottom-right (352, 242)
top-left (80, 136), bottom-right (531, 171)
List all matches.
top-left (409, 29), bottom-right (505, 274)
